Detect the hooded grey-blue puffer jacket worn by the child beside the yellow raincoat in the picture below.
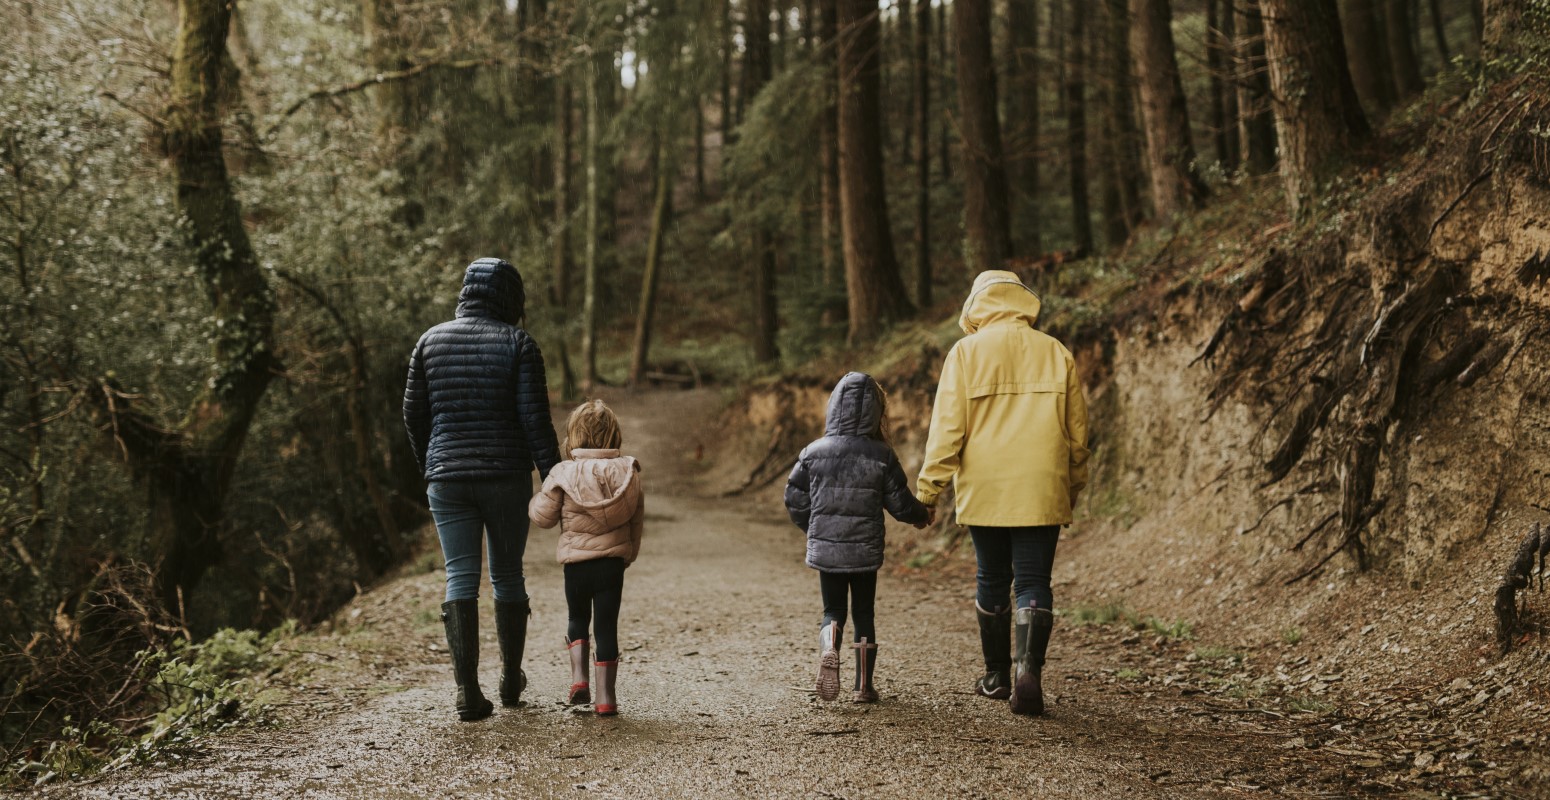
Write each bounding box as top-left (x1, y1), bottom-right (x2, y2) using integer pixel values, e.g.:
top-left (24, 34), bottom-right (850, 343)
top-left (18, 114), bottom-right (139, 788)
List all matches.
top-left (786, 372), bottom-right (925, 572)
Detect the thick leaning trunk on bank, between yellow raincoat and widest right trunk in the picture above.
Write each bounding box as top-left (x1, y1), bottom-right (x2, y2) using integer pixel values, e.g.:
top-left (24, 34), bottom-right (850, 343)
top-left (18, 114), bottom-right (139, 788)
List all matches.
top-left (1130, 0), bottom-right (1206, 222)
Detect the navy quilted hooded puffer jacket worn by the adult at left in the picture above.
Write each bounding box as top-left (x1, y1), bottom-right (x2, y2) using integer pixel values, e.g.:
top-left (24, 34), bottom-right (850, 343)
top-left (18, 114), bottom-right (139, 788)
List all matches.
top-left (403, 259), bottom-right (560, 481)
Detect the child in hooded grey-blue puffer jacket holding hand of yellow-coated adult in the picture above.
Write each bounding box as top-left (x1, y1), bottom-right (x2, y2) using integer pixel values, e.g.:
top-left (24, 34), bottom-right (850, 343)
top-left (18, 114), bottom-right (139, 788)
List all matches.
top-left (786, 372), bottom-right (927, 702)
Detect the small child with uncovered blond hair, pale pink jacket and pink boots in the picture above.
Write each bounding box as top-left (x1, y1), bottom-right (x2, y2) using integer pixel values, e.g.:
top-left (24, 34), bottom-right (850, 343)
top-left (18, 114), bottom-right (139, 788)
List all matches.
top-left (527, 400), bottom-right (646, 716)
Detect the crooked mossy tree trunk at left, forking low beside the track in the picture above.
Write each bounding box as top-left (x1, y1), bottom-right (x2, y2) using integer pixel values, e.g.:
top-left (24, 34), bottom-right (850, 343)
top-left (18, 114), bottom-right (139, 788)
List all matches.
top-left (124, 0), bottom-right (274, 612)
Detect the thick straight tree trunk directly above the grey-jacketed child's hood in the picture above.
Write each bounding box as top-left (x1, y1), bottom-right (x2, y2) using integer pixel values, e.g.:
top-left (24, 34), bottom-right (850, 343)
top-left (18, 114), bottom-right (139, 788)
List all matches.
top-left (837, 0), bottom-right (913, 341)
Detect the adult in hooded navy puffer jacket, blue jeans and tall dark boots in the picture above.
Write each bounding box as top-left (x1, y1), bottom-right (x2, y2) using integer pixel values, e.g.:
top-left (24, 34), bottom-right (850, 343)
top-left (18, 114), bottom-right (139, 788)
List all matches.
top-left (403, 259), bottom-right (560, 721)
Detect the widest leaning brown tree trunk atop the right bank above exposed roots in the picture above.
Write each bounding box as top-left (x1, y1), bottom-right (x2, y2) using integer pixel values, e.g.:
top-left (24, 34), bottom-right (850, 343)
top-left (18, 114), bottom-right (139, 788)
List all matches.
top-left (1260, 0), bottom-right (1370, 214)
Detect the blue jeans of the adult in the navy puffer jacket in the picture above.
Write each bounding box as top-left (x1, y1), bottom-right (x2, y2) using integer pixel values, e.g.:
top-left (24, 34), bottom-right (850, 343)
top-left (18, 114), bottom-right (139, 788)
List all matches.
top-left (425, 474), bottom-right (533, 603)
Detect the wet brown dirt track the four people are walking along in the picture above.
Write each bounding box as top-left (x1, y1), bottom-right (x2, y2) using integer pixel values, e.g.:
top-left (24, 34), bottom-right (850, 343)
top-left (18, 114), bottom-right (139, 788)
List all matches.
top-left (43, 392), bottom-right (1382, 800)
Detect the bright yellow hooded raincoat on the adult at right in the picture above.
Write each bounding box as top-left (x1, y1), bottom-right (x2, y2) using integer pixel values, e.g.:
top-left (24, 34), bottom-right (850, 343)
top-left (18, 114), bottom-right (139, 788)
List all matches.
top-left (916, 270), bottom-right (1088, 527)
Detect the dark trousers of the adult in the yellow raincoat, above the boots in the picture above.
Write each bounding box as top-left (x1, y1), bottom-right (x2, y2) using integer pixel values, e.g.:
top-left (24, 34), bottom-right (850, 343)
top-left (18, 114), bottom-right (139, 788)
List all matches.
top-left (969, 526), bottom-right (1060, 614)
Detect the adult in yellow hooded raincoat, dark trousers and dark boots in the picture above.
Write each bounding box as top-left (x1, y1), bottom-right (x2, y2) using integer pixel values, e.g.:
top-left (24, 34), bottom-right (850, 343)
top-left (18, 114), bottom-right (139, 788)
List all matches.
top-left (916, 270), bottom-right (1088, 715)
